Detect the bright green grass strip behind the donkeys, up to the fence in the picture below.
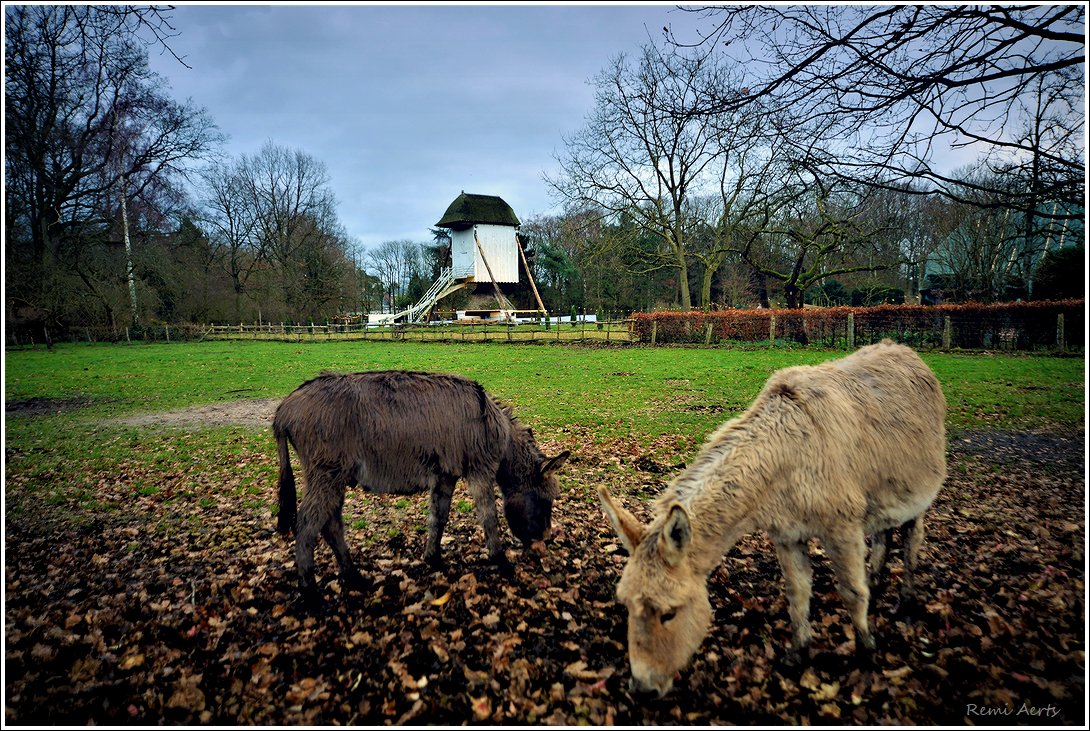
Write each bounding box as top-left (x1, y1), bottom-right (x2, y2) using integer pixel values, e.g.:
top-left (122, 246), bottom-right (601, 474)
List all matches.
top-left (4, 342), bottom-right (1085, 438)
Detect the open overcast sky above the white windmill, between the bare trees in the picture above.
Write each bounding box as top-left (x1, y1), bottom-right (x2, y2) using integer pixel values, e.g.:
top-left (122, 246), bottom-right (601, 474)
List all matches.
top-left (152, 3), bottom-right (706, 247)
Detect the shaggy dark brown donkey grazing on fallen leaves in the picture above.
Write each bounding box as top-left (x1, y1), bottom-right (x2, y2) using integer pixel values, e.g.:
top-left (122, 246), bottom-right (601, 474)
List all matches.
top-left (273, 370), bottom-right (568, 598)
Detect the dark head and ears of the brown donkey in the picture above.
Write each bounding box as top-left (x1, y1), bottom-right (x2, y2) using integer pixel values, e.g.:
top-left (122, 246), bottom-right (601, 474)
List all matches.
top-left (497, 430), bottom-right (570, 546)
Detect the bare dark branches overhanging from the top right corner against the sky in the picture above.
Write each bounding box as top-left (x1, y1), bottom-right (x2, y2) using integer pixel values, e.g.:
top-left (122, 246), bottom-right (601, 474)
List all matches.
top-left (667, 3), bottom-right (1086, 218)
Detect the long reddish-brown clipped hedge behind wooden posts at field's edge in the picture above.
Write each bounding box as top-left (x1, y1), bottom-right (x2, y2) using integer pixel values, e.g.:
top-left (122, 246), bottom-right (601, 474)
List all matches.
top-left (632, 300), bottom-right (1086, 350)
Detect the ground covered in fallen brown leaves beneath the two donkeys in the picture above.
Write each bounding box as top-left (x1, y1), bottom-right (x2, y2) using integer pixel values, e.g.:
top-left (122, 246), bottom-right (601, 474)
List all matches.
top-left (4, 418), bottom-right (1086, 726)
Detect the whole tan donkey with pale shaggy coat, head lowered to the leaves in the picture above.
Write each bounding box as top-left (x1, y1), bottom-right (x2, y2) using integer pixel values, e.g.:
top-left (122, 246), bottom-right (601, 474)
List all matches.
top-left (598, 340), bottom-right (946, 695)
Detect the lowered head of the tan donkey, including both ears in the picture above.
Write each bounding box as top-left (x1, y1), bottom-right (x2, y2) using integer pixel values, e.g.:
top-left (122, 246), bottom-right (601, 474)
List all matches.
top-left (598, 487), bottom-right (712, 696)
